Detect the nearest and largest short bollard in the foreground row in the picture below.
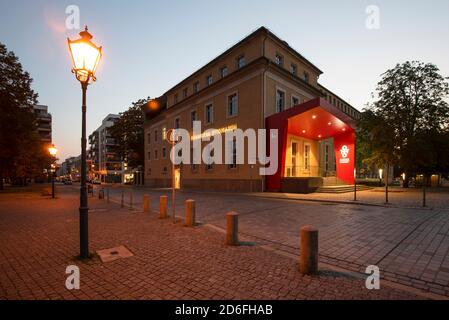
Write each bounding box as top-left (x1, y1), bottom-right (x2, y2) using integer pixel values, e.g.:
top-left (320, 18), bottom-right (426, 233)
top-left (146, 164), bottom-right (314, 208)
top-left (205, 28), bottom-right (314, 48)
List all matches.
top-left (299, 225), bottom-right (318, 274)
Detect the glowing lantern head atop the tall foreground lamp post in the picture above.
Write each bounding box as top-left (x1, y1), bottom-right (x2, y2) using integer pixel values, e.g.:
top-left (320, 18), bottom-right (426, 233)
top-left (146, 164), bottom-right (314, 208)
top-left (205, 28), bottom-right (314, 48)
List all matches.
top-left (67, 26), bottom-right (102, 83)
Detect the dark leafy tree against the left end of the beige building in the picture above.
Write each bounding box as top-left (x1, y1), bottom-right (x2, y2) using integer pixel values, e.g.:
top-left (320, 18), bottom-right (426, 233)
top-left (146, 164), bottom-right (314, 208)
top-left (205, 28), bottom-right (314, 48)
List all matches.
top-left (109, 97), bottom-right (150, 168)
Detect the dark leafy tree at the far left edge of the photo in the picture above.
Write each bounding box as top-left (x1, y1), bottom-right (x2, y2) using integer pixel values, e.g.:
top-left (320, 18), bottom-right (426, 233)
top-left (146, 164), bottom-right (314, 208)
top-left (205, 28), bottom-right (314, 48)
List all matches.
top-left (0, 43), bottom-right (49, 189)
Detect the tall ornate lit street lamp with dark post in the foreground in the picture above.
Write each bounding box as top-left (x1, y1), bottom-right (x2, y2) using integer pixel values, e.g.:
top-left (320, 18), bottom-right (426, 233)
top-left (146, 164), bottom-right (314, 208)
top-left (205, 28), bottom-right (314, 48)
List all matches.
top-left (67, 26), bottom-right (102, 259)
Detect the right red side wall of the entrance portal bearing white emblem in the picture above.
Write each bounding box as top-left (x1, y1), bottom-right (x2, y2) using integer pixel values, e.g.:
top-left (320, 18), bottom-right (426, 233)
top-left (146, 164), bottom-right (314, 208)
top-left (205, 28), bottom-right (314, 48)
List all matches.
top-left (334, 132), bottom-right (355, 184)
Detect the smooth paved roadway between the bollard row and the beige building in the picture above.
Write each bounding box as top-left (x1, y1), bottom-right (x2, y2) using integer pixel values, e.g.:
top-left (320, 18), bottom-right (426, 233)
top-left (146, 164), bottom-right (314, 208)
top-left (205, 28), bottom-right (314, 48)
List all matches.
top-left (103, 188), bottom-right (449, 296)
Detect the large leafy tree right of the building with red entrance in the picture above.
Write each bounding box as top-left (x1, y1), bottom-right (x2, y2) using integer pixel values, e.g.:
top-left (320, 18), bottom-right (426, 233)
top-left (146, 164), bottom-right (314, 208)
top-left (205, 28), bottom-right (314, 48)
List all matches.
top-left (357, 61), bottom-right (449, 187)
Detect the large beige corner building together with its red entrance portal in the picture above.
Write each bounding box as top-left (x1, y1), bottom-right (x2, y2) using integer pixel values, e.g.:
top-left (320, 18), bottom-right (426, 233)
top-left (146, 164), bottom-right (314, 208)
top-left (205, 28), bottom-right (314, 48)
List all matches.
top-left (144, 27), bottom-right (360, 192)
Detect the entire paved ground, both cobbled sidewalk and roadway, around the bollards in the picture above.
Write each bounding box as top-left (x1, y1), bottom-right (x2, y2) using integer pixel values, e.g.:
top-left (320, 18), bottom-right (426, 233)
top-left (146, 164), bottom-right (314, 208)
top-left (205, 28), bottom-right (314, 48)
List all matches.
top-left (0, 185), bottom-right (449, 299)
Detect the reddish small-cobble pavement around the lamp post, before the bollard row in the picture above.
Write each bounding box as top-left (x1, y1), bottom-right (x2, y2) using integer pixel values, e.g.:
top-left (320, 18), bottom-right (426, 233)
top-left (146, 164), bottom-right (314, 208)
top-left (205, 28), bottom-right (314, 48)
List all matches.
top-left (0, 186), bottom-right (428, 299)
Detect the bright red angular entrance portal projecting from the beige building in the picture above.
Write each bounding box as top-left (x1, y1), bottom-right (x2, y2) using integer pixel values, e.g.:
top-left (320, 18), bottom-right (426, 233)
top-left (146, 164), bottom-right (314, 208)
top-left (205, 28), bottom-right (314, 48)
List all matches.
top-left (265, 98), bottom-right (355, 191)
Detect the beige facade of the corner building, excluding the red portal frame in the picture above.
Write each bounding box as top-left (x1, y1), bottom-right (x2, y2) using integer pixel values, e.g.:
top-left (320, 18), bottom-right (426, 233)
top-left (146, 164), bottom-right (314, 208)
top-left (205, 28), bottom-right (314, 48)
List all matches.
top-left (144, 27), bottom-right (360, 191)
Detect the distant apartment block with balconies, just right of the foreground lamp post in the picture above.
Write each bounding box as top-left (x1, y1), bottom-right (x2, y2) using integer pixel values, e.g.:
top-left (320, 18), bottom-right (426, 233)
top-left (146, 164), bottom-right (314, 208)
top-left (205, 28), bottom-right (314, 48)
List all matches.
top-left (88, 114), bottom-right (124, 183)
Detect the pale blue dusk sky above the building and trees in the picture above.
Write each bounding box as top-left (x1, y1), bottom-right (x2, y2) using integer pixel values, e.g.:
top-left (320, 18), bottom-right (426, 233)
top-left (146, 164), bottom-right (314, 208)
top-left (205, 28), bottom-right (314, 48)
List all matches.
top-left (0, 0), bottom-right (449, 160)
